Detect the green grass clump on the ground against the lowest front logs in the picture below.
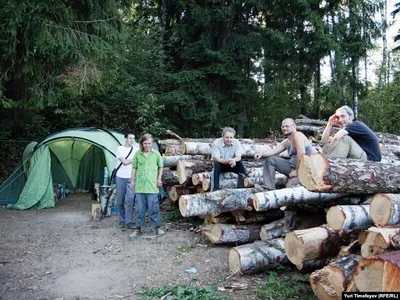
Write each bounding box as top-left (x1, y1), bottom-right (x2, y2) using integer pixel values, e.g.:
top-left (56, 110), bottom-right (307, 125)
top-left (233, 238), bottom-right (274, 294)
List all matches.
top-left (257, 272), bottom-right (315, 300)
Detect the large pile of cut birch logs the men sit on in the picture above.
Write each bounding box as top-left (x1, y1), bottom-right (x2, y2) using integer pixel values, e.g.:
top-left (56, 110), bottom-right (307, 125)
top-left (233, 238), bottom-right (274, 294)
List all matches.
top-left (159, 119), bottom-right (400, 299)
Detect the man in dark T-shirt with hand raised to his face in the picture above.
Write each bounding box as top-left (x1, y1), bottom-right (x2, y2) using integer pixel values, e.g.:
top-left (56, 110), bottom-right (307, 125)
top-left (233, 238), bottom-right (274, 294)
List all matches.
top-left (321, 106), bottom-right (381, 161)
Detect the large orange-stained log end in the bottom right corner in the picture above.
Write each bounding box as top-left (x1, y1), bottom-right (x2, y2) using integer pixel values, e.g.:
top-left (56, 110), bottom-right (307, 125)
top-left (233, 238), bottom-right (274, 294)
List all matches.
top-left (353, 251), bottom-right (400, 292)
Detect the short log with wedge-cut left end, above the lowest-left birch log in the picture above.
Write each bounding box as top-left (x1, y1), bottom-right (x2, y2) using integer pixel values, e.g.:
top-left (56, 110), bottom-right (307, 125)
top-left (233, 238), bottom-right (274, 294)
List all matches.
top-left (204, 224), bottom-right (262, 244)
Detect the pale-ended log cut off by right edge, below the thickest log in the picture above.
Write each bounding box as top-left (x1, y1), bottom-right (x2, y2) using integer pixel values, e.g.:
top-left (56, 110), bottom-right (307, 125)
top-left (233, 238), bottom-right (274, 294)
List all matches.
top-left (369, 194), bottom-right (400, 226)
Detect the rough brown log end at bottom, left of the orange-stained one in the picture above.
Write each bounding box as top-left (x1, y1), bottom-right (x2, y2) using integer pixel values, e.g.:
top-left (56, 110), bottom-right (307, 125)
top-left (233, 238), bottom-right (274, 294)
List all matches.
top-left (310, 267), bottom-right (343, 300)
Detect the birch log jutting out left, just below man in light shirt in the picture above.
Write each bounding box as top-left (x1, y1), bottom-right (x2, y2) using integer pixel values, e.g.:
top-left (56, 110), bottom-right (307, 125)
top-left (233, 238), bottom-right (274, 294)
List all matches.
top-left (179, 189), bottom-right (254, 217)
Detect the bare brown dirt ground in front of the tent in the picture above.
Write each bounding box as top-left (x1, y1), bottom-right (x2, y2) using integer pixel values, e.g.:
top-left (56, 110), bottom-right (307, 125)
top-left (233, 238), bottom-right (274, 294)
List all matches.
top-left (0, 194), bottom-right (308, 300)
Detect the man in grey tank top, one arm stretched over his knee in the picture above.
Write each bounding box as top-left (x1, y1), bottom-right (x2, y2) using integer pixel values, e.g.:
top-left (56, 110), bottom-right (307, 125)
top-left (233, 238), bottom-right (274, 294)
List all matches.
top-left (254, 118), bottom-right (316, 190)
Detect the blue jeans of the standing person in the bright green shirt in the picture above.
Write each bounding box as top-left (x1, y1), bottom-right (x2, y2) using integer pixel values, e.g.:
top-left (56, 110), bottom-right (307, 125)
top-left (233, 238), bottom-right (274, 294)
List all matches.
top-left (135, 193), bottom-right (161, 228)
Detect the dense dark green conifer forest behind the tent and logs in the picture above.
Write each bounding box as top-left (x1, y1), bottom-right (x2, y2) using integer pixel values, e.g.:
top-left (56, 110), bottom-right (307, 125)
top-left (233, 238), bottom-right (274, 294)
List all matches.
top-left (0, 0), bottom-right (400, 180)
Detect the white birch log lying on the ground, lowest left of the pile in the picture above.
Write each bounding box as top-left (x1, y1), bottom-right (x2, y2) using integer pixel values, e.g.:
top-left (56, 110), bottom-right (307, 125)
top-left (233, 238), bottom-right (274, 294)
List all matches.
top-left (228, 238), bottom-right (289, 274)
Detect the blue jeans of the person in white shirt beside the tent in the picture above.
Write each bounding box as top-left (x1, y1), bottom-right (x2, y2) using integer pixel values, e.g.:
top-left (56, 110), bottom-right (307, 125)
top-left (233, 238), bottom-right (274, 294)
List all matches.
top-left (115, 176), bottom-right (135, 224)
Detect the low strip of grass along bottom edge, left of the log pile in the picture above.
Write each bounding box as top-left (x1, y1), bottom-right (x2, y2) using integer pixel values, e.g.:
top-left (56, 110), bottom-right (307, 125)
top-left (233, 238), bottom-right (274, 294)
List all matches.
top-left (138, 285), bottom-right (229, 300)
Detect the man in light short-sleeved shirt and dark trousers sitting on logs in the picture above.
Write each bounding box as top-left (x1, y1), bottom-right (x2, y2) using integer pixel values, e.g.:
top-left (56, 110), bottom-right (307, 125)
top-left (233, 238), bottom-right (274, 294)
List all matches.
top-left (211, 127), bottom-right (246, 191)
